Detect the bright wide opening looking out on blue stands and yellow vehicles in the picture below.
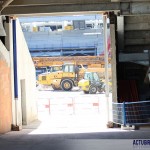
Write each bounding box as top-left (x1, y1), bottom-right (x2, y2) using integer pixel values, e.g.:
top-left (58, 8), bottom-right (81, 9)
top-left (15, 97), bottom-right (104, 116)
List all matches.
top-left (20, 14), bottom-right (112, 133)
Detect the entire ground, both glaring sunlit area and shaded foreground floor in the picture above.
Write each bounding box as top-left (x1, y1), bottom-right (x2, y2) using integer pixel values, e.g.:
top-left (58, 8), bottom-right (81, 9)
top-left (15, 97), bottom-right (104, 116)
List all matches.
top-left (0, 89), bottom-right (150, 150)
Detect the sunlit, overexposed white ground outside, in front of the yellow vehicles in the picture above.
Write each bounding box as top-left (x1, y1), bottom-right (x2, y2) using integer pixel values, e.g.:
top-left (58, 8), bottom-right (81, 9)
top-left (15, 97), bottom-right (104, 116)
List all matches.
top-left (24, 88), bottom-right (112, 133)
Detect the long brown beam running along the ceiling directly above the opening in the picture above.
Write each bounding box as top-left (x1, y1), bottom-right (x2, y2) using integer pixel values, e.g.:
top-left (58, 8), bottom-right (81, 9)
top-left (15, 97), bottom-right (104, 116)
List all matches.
top-left (2, 3), bottom-right (120, 15)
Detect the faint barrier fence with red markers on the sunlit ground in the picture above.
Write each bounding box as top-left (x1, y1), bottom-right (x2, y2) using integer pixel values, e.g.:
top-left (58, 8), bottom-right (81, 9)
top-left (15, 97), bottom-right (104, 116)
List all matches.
top-left (37, 96), bottom-right (100, 115)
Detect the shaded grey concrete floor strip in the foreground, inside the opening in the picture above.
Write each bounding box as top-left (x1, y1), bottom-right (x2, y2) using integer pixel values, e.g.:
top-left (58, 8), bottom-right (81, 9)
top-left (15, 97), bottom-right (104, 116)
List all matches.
top-left (0, 129), bottom-right (150, 150)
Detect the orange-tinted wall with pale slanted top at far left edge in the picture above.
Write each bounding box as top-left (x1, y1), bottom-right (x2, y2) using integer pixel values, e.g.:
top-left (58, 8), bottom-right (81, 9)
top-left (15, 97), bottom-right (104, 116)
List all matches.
top-left (0, 41), bottom-right (12, 133)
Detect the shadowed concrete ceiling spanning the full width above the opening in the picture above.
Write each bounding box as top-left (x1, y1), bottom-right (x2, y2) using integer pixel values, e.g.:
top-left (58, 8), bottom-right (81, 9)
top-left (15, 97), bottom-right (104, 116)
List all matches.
top-left (0, 0), bottom-right (150, 15)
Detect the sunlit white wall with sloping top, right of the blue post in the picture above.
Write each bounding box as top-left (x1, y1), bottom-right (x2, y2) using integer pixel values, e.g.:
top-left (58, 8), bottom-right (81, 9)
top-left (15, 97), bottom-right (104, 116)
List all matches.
top-left (11, 20), bottom-right (37, 126)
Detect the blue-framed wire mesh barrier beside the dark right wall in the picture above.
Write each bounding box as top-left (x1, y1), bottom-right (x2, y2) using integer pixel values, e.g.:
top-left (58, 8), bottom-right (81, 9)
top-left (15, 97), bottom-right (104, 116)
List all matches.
top-left (113, 101), bottom-right (150, 126)
